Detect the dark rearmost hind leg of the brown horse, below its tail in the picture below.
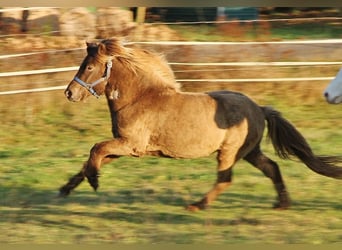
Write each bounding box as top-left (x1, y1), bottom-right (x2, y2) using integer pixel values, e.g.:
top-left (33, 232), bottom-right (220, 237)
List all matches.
top-left (244, 147), bottom-right (291, 209)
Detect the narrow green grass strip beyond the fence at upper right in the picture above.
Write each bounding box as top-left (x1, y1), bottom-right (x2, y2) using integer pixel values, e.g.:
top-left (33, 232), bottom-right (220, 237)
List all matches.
top-left (170, 22), bottom-right (342, 41)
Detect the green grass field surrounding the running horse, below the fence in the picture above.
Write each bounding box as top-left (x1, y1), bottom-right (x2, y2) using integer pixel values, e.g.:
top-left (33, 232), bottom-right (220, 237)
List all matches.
top-left (0, 88), bottom-right (342, 244)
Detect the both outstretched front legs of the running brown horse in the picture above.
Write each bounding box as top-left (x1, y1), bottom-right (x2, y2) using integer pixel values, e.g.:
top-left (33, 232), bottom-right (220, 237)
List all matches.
top-left (60, 139), bottom-right (132, 196)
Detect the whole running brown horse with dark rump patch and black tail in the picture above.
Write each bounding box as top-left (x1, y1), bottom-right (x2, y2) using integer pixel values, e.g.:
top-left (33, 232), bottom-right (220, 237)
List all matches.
top-left (59, 38), bottom-right (342, 211)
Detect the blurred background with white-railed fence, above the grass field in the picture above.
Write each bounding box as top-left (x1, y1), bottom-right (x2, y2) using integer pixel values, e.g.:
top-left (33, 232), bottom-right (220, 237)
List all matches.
top-left (0, 7), bottom-right (342, 98)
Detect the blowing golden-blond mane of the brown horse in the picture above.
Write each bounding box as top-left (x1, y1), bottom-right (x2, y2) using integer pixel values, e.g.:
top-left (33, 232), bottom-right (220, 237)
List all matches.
top-left (92, 38), bottom-right (180, 90)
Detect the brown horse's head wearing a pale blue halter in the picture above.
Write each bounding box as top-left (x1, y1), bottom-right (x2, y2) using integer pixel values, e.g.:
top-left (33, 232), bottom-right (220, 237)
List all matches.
top-left (64, 40), bottom-right (119, 102)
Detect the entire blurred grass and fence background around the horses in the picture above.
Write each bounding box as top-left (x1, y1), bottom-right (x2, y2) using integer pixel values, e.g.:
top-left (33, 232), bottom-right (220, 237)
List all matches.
top-left (0, 7), bottom-right (342, 243)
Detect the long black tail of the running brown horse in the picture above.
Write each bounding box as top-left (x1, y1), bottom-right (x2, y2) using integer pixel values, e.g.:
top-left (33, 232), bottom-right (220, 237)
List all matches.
top-left (261, 107), bottom-right (342, 179)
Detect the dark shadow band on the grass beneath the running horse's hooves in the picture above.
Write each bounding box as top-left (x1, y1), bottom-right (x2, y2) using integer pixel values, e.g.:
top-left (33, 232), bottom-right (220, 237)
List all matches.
top-left (0, 184), bottom-right (342, 229)
